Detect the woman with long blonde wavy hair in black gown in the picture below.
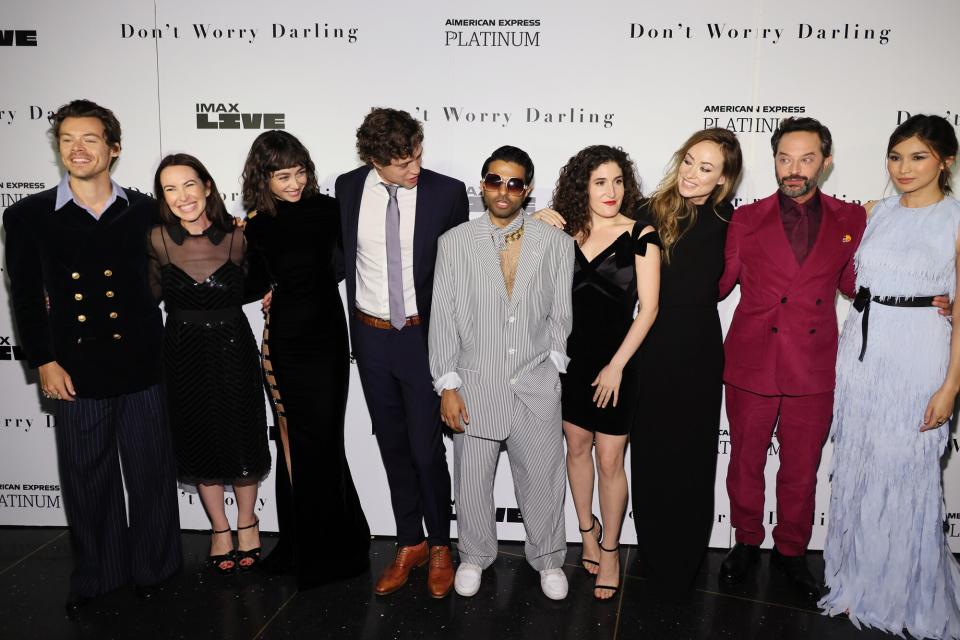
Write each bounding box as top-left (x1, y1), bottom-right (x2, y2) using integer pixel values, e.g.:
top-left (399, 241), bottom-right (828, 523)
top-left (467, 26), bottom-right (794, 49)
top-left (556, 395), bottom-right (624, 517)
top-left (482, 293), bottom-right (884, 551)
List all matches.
top-left (630, 129), bottom-right (742, 601)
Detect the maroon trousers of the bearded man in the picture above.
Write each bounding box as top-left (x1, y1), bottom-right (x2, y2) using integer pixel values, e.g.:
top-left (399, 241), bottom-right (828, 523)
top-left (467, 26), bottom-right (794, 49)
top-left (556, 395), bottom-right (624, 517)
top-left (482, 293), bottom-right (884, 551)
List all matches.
top-left (726, 385), bottom-right (833, 556)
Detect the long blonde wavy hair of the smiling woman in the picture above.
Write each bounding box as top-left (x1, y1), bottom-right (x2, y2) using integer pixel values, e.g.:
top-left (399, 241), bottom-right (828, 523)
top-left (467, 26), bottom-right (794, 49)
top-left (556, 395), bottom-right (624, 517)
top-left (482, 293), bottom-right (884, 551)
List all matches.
top-left (648, 127), bottom-right (743, 263)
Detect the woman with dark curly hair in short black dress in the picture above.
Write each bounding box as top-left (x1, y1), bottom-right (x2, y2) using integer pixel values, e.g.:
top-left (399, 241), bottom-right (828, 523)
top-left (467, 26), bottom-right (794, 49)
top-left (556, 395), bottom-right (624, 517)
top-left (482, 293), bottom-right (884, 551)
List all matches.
top-left (538, 145), bottom-right (660, 600)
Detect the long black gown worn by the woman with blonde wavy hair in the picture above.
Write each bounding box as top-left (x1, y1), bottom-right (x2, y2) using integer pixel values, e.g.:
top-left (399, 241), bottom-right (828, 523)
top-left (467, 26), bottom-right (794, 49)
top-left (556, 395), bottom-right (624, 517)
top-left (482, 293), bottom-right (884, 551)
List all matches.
top-left (630, 203), bottom-right (733, 600)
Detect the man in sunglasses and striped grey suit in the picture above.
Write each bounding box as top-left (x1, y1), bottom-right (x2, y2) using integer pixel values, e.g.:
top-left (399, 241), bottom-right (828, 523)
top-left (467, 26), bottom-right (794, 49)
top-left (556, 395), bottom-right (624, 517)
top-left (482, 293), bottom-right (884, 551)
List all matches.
top-left (429, 146), bottom-right (574, 600)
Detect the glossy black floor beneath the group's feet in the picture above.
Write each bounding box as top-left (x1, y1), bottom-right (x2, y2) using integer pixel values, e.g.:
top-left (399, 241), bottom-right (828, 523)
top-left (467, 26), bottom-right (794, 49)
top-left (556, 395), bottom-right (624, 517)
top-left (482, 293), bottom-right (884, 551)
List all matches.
top-left (0, 527), bottom-right (893, 640)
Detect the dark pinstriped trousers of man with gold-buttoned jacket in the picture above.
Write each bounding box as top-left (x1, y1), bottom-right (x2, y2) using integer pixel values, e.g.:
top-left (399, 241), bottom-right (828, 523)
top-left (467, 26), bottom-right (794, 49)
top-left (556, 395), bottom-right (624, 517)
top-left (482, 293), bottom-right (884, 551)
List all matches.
top-left (55, 385), bottom-right (181, 597)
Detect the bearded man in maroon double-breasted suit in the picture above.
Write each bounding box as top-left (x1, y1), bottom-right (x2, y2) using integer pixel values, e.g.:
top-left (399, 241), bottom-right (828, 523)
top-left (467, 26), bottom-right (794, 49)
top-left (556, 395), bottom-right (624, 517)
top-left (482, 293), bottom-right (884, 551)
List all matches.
top-left (720, 118), bottom-right (866, 599)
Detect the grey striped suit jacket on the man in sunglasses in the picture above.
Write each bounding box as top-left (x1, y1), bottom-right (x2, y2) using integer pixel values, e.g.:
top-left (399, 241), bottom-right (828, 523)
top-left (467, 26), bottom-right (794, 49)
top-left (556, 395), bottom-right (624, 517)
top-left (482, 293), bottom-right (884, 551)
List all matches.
top-left (429, 214), bottom-right (574, 440)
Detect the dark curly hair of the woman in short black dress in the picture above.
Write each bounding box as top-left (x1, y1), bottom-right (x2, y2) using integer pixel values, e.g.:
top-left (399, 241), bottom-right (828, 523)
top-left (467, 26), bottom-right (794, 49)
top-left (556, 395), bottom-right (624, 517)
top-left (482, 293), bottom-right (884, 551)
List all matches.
top-left (552, 144), bottom-right (643, 244)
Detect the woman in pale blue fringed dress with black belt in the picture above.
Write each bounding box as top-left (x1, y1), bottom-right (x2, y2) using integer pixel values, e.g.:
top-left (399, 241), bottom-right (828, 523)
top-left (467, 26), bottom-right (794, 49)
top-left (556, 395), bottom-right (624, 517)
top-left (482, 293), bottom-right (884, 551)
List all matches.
top-left (820, 116), bottom-right (960, 638)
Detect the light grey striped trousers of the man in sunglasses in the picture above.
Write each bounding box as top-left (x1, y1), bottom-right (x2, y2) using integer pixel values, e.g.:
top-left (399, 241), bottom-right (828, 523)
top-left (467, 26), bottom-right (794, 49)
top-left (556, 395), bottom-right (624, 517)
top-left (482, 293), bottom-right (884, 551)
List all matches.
top-left (453, 398), bottom-right (567, 571)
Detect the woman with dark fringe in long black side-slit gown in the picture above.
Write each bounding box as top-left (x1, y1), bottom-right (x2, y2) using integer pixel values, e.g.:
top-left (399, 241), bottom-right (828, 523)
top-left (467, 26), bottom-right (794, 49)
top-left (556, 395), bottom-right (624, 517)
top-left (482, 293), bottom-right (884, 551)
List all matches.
top-left (243, 130), bottom-right (370, 588)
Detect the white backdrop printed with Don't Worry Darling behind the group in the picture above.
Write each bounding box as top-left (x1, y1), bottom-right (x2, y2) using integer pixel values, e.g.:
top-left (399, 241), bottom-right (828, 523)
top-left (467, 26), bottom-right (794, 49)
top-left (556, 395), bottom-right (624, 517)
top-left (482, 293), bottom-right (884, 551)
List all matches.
top-left (0, 0), bottom-right (960, 551)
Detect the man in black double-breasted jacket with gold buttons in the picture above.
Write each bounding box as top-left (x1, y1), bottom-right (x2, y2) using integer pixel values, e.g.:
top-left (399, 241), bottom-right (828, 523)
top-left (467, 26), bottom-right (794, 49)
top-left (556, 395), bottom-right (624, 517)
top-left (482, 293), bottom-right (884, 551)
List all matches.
top-left (3, 100), bottom-right (181, 618)
